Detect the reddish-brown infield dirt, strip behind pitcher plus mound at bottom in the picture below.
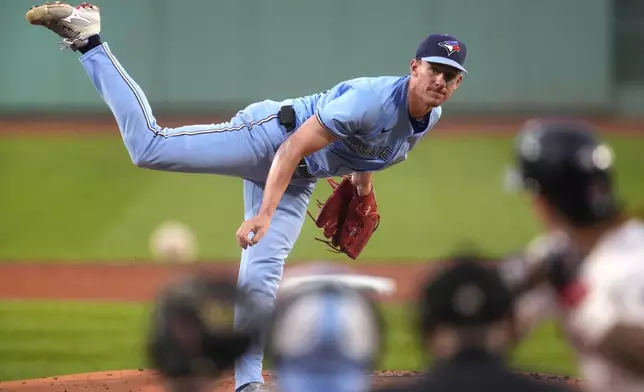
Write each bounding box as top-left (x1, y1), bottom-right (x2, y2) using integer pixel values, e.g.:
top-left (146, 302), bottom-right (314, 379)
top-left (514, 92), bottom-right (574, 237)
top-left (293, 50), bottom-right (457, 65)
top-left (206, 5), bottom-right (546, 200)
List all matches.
top-left (0, 262), bottom-right (579, 392)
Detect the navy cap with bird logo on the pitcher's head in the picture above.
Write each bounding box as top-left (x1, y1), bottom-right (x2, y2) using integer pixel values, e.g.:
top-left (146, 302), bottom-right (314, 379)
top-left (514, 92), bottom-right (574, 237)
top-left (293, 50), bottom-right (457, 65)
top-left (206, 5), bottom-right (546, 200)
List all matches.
top-left (416, 34), bottom-right (467, 73)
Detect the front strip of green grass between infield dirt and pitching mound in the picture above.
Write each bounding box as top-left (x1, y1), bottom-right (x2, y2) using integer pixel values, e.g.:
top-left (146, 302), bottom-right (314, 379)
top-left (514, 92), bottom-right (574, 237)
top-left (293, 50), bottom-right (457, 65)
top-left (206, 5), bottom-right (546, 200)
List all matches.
top-left (0, 301), bottom-right (576, 381)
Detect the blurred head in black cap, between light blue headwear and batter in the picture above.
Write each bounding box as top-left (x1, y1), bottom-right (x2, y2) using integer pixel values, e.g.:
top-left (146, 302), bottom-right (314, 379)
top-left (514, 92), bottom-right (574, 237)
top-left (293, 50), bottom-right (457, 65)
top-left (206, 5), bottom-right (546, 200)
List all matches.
top-left (418, 255), bottom-right (514, 357)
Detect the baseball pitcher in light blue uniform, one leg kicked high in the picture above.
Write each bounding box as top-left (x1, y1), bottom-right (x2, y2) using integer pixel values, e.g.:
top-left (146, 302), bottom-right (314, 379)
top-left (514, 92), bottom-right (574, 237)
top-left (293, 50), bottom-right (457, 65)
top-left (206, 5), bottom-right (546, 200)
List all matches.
top-left (26, 2), bottom-right (467, 392)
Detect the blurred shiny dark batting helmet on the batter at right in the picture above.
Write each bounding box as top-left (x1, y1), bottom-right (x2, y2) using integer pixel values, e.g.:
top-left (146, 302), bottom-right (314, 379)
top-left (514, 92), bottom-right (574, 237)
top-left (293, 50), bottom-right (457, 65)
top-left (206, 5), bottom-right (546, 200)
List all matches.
top-left (515, 119), bottom-right (620, 226)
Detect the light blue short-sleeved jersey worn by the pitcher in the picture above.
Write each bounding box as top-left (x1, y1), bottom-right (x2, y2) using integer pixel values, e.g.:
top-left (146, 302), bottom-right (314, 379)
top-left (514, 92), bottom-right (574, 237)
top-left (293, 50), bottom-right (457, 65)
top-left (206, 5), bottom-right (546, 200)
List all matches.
top-left (293, 76), bottom-right (441, 177)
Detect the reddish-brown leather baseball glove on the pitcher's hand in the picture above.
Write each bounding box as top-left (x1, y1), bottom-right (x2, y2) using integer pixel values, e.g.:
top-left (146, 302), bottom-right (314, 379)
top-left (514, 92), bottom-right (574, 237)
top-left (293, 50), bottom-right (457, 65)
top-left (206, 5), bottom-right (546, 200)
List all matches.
top-left (308, 177), bottom-right (380, 259)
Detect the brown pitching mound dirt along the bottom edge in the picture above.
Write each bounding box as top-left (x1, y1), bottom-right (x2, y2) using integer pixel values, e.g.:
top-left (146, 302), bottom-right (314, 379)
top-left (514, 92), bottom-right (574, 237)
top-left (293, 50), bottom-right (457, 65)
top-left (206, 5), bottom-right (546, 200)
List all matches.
top-left (0, 369), bottom-right (580, 392)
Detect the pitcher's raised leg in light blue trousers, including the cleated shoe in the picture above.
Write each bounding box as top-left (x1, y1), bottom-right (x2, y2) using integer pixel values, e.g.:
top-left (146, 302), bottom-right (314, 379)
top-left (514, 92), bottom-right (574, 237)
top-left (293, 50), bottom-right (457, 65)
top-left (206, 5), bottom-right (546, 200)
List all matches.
top-left (27, 3), bottom-right (281, 178)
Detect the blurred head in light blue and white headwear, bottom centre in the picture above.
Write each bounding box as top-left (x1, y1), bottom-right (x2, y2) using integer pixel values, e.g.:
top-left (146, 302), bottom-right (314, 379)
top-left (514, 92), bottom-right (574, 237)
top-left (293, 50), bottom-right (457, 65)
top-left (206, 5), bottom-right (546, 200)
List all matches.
top-left (269, 282), bottom-right (382, 392)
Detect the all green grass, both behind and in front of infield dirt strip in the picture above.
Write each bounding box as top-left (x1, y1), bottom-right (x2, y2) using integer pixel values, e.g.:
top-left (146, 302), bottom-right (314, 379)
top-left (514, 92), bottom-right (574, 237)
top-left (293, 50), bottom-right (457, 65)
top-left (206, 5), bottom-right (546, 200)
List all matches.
top-left (0, 134), bottom-right (644, 380)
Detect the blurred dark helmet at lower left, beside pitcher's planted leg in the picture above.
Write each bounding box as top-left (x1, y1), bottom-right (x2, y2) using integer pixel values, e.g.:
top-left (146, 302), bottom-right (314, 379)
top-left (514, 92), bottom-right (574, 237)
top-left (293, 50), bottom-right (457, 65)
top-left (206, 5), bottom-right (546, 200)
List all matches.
top-left (147, 272), bottom-right (259, 380)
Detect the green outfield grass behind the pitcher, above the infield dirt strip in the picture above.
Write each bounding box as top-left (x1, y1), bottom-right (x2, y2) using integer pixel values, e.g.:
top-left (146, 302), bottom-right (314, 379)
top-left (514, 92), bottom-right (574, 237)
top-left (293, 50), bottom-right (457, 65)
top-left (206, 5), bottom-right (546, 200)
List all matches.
top-left (0, 134), bottom-right (644, 262)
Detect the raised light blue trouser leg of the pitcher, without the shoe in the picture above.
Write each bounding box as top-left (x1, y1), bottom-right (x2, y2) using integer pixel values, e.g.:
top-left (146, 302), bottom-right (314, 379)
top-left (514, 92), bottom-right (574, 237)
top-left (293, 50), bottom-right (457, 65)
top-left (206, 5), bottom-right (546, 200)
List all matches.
top-left (81, 43), bottom-right (279, 177)
